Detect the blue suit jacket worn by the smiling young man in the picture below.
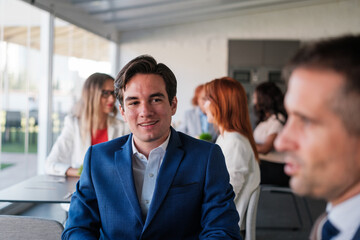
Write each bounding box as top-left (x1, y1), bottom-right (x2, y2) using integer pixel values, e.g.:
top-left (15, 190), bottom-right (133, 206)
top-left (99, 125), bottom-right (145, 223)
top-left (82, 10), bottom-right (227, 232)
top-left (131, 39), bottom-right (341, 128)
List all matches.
top-left (62, 129), bottom-right (241, 240)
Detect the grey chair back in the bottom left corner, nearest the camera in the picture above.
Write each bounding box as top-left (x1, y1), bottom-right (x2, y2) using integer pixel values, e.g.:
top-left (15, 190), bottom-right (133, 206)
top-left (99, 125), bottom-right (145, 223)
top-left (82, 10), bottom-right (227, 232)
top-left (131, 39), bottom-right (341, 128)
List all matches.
top-left (0, 215), bottom-right (64, 240)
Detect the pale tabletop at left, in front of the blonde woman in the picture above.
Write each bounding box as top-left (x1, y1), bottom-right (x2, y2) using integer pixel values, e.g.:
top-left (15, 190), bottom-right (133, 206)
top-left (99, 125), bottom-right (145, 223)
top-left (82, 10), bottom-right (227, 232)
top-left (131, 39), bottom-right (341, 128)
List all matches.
top-left (0, 175), bottom-right (79, 203)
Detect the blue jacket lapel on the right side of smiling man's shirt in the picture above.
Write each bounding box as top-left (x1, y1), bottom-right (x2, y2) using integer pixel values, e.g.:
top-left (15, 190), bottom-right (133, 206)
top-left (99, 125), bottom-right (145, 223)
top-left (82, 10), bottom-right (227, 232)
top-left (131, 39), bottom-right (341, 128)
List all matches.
top-left (144, 128), bottom-right (184, 229)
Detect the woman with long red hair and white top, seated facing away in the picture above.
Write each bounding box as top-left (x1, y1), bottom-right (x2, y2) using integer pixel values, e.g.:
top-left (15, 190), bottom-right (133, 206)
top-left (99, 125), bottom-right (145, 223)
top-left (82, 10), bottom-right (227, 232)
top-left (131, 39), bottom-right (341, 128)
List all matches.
top-left (205, 77), bottom-right (260, 230)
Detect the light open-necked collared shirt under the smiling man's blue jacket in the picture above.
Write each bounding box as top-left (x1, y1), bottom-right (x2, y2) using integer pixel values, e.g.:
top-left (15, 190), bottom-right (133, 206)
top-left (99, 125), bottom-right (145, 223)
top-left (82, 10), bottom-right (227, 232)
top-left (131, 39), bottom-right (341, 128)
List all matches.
top-left (131, 132), bottom-right (171, 218)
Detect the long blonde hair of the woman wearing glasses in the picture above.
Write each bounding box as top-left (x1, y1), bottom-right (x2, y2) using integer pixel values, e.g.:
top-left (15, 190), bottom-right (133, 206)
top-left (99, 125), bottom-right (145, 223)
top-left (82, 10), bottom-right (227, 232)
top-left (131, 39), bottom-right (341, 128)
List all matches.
top-left (72, 73), bottom-right (117, 142)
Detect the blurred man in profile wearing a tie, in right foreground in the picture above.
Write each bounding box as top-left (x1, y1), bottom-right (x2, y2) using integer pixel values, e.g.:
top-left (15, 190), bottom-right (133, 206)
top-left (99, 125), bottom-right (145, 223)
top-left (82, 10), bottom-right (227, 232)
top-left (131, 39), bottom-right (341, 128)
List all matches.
top-left (275, 35), bottom-right (360, 240)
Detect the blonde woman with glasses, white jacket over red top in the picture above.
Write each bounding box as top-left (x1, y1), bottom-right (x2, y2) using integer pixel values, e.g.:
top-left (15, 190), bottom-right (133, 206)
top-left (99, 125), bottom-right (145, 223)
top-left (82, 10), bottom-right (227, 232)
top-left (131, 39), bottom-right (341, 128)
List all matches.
top-left (45, 73), bottom-right (130, 176)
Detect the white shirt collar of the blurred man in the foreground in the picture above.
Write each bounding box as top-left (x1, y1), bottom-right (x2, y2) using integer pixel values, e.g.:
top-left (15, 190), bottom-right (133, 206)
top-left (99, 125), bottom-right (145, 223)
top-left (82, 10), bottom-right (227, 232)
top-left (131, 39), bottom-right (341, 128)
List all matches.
top-left (326, 194), bottom-right (360, 240)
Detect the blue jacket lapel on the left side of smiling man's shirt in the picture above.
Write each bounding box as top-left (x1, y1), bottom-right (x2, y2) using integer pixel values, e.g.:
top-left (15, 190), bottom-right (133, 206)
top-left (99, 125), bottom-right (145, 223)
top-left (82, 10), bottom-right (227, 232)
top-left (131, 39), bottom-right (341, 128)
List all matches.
top-left (115, 135), bottom-right (144, 224)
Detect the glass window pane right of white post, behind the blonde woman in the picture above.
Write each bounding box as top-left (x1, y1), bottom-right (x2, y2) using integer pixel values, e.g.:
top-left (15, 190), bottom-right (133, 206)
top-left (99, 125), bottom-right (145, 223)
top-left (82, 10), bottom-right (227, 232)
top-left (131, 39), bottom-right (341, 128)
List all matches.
top-left (52, 18), bottom-right (111, 143)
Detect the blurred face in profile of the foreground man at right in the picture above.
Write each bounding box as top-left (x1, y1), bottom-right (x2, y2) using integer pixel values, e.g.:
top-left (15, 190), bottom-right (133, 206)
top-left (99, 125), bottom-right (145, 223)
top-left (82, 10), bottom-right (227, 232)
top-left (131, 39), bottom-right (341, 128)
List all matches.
top-left (275, 68), bottom-right (360, 204)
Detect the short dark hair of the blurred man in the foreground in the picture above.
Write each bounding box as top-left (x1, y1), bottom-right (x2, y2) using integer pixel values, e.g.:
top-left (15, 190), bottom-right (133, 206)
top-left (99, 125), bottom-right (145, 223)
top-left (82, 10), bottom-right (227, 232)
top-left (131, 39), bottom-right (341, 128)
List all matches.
top-left (284, 35), bottom-right (360, 135)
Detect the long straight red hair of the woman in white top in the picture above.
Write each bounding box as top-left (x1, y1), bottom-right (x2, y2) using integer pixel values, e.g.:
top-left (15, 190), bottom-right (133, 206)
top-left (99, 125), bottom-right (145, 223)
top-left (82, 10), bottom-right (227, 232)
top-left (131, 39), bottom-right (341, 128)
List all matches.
top-left (205, 77), bottom-right (259, 161)
